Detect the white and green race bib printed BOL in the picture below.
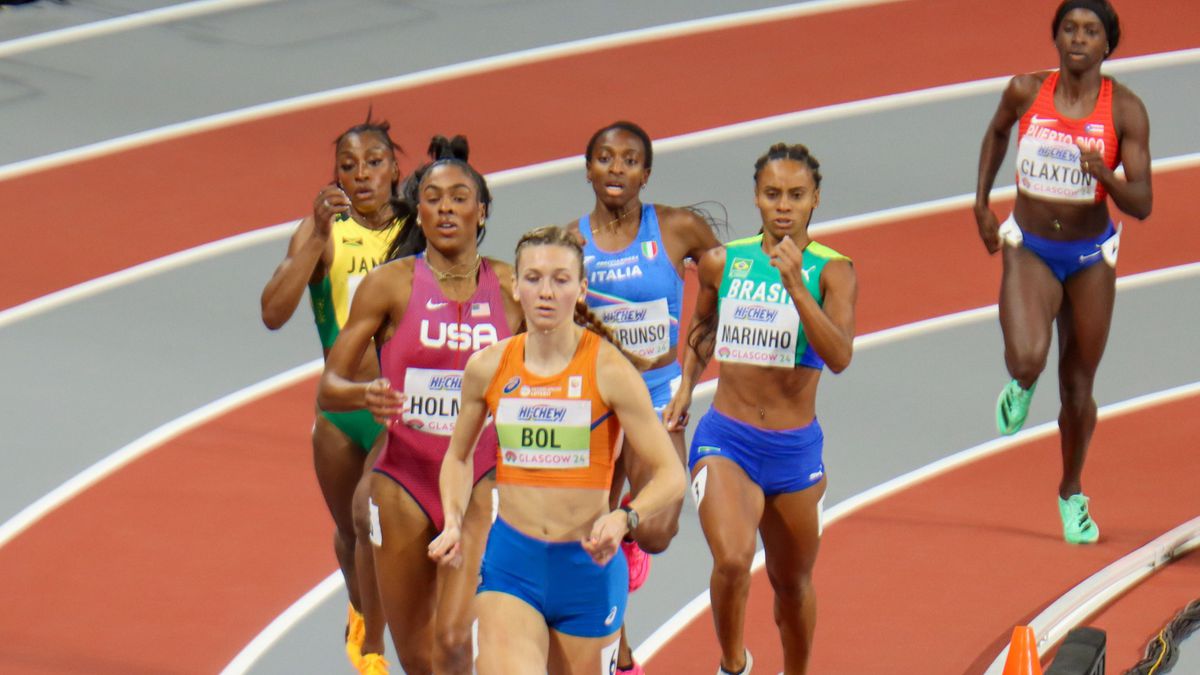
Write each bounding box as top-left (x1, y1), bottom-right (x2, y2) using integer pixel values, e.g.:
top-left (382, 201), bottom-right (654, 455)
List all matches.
top-left (496, 399), bottom-right (592, 468)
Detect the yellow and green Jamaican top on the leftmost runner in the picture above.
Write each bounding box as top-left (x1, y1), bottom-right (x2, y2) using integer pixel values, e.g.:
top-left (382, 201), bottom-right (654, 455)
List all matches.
top-left (308, 214), bottom-right (404, 350)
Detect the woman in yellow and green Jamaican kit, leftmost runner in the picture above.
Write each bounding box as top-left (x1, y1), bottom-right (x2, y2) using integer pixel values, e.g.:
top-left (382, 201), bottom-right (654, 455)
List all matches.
top-left (262, 119), bottom-right (410, 668)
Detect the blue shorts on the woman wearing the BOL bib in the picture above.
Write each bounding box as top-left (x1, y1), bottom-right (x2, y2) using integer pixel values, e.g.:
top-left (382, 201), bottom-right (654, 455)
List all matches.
top-left (479, 518), bottom-right (629, 638)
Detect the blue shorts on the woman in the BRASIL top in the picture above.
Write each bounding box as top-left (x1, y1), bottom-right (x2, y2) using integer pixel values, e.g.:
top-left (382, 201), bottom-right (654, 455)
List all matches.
top-left (688, 408), bottom-right (824, 496)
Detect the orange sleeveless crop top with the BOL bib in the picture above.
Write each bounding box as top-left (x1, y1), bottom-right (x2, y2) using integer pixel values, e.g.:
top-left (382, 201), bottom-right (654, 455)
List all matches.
top-left (485, 330), bottom-right (620, 490)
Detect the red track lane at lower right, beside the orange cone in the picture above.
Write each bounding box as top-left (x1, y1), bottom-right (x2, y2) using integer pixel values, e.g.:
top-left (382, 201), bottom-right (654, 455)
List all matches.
top-left (646, 395), bottom-right (1200, 675)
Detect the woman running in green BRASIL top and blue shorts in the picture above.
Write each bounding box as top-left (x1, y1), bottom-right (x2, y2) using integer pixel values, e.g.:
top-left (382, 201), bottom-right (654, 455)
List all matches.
top-left (665, 143), bottom-right (857, 675)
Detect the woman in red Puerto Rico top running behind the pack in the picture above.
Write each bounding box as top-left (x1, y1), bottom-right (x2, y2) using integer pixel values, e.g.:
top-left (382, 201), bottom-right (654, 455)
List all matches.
top-left (974, 0), bottom-right (1153, 544)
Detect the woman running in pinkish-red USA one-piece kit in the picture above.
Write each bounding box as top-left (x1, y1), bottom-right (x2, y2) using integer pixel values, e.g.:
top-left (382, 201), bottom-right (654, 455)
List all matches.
top-left (320, 137), bottom-right (522, 675)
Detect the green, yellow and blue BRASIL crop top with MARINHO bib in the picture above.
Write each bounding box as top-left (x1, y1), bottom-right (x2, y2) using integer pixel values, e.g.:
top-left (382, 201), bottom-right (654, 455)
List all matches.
top-left (715, 234), bottom-right (850, 369)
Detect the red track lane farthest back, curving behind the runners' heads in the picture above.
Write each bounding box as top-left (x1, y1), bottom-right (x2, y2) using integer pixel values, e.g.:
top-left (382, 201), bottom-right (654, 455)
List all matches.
top-left (7, 0), bottom-right (1200, 307)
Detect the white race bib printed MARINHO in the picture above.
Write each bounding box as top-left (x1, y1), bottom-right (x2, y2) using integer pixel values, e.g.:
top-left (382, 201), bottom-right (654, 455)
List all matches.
top-left (716, 298), bottom-right (800, 368)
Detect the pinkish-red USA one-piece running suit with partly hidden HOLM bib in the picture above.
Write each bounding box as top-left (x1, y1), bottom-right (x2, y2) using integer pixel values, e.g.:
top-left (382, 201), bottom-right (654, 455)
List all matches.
top-left (374, 255), bottom-right (510, 531)
